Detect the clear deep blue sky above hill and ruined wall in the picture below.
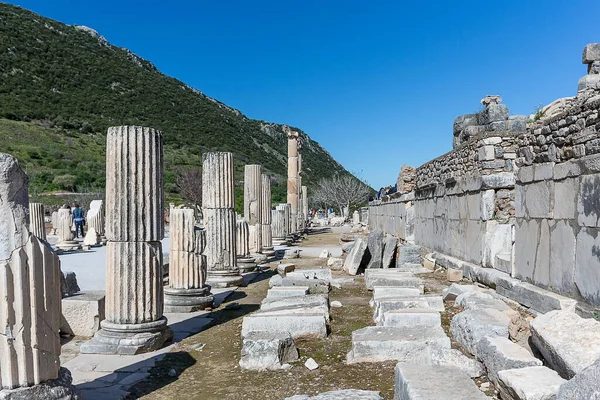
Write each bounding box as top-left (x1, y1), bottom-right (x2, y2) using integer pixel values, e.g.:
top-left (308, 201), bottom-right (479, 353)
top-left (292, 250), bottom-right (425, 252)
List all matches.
top-left (9, 0), bottom-right (600, 188)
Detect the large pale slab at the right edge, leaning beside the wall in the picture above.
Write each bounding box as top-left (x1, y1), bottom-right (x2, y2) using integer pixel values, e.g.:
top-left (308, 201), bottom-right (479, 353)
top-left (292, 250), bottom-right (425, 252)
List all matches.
top-left (530, 310), bottom-right (600, 379)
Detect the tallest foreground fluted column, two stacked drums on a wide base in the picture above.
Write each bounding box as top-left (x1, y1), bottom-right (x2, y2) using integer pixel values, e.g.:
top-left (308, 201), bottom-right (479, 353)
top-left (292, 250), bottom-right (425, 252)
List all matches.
top-left (81, 126), bottom-right (173, 355)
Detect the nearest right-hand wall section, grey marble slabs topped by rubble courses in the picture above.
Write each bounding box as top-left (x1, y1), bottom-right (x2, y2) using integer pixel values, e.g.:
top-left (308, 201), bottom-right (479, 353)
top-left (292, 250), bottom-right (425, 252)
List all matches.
top-left (513, 91), bottom-right (600, 305)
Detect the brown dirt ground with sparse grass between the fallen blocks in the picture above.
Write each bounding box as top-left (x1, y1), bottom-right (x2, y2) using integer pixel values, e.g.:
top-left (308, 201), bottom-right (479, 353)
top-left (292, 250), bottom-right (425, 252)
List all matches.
top-left (128, 230), bottom-right (516, 400)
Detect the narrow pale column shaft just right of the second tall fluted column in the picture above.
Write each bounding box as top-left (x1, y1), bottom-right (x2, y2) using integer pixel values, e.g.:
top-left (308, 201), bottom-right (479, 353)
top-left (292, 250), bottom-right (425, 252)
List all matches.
top-left (244, 164), bottom-right (263, 253)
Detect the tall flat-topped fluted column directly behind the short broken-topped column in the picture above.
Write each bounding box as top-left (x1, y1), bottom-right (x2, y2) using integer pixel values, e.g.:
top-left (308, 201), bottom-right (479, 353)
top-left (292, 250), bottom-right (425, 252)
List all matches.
top-left (202, 152), bottom-right (243, 287)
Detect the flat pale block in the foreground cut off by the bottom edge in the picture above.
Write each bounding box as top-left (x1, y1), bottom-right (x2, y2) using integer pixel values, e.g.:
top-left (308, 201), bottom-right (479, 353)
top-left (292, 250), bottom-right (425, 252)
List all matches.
top-left (394, 362), bottom-right (489, 400)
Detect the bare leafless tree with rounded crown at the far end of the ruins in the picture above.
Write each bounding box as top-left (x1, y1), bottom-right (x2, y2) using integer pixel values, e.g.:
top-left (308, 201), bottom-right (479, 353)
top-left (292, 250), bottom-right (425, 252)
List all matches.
top-left (312, 175), bottom-right (372, 217)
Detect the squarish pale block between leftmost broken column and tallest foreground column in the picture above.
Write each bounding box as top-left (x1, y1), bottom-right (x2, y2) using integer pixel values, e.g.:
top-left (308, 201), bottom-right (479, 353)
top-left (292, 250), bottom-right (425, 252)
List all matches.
top-left (60, 290), bottom-right (106, 337)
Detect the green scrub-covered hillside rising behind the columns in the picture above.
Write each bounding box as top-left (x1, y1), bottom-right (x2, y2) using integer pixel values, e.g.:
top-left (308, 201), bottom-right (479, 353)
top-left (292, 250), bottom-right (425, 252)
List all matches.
top-left (0, 3), bottom-right (347, 200)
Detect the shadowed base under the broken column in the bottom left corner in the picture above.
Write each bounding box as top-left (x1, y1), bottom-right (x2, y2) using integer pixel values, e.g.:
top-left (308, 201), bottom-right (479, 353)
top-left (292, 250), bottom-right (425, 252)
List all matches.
top-left (0, 368), bottom-right (82, 400)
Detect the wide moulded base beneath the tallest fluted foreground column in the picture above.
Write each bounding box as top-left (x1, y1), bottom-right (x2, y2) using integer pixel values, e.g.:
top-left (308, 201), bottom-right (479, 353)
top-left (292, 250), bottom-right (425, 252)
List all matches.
top-left (80, 317), bottom-right (173, 356)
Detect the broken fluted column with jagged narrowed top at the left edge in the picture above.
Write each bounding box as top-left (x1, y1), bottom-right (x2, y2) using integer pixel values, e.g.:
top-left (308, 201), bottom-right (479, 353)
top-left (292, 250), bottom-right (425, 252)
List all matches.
top-left (0, 153), bottom-right (77, 400)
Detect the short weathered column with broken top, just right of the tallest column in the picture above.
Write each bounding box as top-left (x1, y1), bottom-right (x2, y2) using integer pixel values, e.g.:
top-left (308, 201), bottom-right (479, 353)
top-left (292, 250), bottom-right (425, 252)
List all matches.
top-left (165, 208), bottom-right (214, 312)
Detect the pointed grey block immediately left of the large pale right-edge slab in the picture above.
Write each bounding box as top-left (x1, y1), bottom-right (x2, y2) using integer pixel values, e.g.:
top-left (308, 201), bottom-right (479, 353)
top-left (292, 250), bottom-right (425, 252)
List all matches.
top-left (477, 336), bottom-right (542, 384)
